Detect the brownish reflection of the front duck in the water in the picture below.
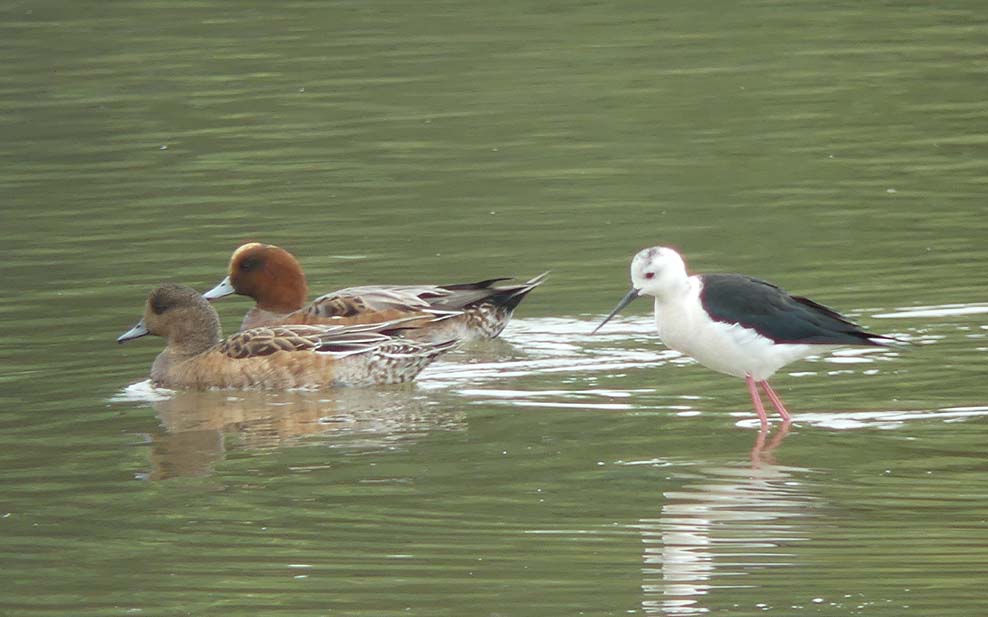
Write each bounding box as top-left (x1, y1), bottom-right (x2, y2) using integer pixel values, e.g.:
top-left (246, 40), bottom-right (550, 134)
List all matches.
top-left (139, 385), bottom-right (461, 480)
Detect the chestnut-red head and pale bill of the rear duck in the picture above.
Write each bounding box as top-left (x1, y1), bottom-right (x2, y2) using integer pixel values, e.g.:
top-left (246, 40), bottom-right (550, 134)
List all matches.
top-left (203, 242), bottom-right (309, 313)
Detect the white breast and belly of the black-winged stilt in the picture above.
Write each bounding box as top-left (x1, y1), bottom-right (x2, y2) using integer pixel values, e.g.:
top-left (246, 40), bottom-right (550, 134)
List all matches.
top-left (655, 276), bottom-right (827, 381)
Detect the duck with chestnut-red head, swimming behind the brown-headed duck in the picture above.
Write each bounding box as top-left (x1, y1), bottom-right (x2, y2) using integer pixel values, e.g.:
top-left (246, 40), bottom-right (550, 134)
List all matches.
top-left (203, 242), bottom-right (549, 341)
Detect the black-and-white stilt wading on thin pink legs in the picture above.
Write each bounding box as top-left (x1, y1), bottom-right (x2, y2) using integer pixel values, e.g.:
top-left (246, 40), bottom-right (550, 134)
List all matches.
top-left (591, 246), bottom-right (902, 427)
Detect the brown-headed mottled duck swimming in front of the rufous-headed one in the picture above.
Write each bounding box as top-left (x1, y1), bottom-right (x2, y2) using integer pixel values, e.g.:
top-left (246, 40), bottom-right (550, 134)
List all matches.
top-left (117, 285), bottom-right (455, 390)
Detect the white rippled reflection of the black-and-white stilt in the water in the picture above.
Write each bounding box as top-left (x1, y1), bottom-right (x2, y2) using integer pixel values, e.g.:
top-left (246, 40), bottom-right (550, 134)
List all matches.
top-left (640, 423), bottom-right (815, 615)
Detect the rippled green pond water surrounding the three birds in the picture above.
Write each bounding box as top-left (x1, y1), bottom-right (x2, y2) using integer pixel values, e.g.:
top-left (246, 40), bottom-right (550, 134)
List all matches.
top-left (0, 0), bottom-right (988, 617)
